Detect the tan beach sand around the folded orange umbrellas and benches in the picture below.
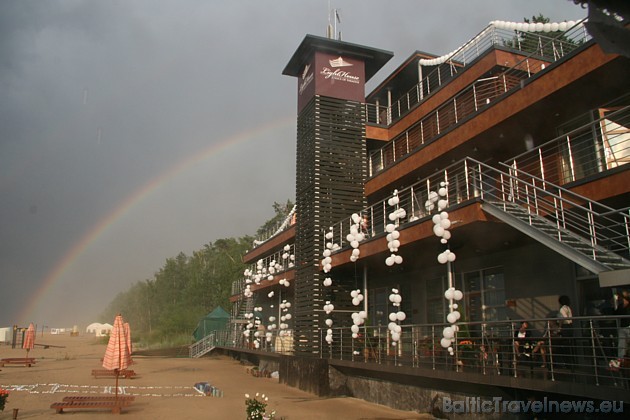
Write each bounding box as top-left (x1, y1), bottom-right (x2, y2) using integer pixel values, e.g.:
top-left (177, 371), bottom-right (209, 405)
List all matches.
top-left (0, 333), bottom-right (432, 420)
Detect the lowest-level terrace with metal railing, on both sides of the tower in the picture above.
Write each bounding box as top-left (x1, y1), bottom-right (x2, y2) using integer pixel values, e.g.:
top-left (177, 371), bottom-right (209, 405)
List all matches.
top-left (210, 316), bottom-right (630, 404)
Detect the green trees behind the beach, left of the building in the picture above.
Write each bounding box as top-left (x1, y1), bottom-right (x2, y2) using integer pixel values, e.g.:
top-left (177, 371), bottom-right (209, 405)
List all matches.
top-left (102, 200), bottom-right (293, 343)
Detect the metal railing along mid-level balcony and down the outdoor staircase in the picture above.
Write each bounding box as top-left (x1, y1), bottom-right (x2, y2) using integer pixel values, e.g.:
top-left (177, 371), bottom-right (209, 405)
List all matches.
top-left (322, 158), bottom-right (630, 263)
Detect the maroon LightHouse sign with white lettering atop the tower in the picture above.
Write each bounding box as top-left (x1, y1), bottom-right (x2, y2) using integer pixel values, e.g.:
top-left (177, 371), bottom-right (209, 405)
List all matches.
top-left (298, 51), bottom-right (365, 112)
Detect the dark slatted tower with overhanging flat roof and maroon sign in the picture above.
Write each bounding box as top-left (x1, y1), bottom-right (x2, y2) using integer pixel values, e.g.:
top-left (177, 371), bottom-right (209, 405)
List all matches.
top-left (283, 35), bottom-right (393, 354)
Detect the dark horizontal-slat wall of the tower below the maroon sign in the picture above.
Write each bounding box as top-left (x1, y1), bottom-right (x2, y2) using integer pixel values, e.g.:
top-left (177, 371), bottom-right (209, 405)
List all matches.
top-left (293, 96), bottom-right (367, 354)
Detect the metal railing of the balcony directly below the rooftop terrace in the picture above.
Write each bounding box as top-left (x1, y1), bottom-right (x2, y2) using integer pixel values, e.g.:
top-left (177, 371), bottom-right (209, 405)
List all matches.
top-left (368, 20), bottom-right (588, 176)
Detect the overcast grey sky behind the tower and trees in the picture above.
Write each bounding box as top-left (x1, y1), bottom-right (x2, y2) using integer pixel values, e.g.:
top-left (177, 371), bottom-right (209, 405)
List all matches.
top-left (0, 0), bottom-right (585, 326)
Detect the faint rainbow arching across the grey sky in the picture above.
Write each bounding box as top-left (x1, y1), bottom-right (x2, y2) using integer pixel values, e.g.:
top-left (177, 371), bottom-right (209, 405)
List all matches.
top-left (17, 116), bottom-right (295, 322)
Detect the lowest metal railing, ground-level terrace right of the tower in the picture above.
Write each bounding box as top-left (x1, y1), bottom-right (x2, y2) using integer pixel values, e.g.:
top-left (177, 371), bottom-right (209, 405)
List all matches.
top-left (320, 316), bottom-right (629, 386)
